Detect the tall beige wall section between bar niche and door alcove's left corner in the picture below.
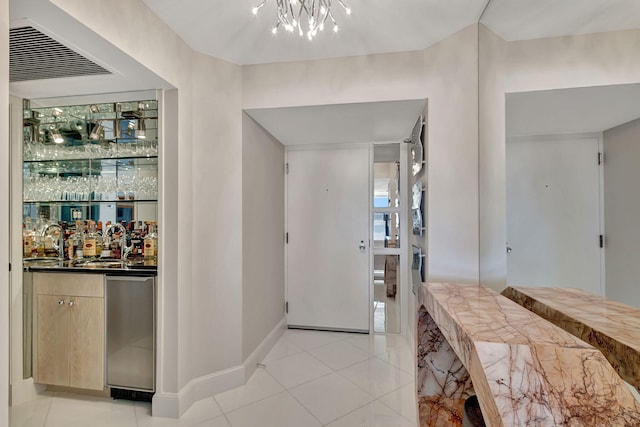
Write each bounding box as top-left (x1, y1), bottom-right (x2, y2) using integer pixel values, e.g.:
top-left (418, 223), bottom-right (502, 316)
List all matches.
top-left (190, 54), bottom-right (243, 377)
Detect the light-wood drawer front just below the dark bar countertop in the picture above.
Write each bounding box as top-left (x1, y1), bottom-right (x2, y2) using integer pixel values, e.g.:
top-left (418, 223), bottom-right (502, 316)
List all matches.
top-left (33, 273), bottom-right (104, 298)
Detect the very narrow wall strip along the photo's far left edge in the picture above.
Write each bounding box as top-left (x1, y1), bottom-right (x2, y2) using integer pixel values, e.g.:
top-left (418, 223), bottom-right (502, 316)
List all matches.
top-left (0, 0), bottom-right (11, 425)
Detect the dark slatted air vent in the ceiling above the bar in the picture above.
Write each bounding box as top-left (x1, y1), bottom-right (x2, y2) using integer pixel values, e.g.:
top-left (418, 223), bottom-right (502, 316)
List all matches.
top-left (9, 27), bottom-right (111, 82)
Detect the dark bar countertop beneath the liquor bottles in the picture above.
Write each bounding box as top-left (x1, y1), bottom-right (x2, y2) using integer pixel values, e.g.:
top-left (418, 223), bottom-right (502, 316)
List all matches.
top-left (22, 258), bottom-right (158, 276)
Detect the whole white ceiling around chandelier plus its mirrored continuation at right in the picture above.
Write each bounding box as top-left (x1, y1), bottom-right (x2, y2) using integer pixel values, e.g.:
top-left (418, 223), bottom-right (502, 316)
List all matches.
top-left (143, 0), bottom-right (640, 64)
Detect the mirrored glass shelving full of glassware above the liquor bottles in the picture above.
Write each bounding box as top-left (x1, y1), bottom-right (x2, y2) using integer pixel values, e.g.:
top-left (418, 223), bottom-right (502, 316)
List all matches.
top-left (23, 100), bottom-right (158, 222)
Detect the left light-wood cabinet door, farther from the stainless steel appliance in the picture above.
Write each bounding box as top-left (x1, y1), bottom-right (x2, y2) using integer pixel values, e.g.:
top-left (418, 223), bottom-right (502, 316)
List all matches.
top-left (35, 295), bottom-right (69, 385)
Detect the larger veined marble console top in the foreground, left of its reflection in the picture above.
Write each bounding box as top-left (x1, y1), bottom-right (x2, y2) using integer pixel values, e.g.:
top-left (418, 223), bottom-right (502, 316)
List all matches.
top-left (419, 283), bottom-right (640, 426)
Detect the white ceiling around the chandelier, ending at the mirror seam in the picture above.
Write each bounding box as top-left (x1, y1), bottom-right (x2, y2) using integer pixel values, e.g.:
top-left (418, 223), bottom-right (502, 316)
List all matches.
top-left (144, 0), bottom-right (488, 64)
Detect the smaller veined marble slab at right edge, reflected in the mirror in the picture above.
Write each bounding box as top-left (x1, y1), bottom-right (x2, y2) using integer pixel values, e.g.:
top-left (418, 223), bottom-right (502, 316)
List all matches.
top-left (502, 286), bottom-right (640, 390)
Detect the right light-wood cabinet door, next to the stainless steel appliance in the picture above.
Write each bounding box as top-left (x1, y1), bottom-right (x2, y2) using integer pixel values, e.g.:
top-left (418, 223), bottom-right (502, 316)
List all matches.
top-left (67, 297), bottom-right (104, 390)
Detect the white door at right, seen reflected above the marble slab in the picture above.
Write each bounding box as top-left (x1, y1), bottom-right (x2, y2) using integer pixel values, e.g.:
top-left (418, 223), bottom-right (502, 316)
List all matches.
top-left (506, 137), bottom-right (602, 294)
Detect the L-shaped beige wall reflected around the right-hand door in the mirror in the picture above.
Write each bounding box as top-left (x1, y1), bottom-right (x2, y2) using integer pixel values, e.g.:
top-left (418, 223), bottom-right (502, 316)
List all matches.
top-left (480, 26), bottom-right (640, 290)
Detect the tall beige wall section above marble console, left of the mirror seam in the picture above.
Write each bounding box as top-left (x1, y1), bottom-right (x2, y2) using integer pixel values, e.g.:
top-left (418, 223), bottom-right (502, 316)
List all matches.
top-left (424, 25), bottom-right (479, 283)
